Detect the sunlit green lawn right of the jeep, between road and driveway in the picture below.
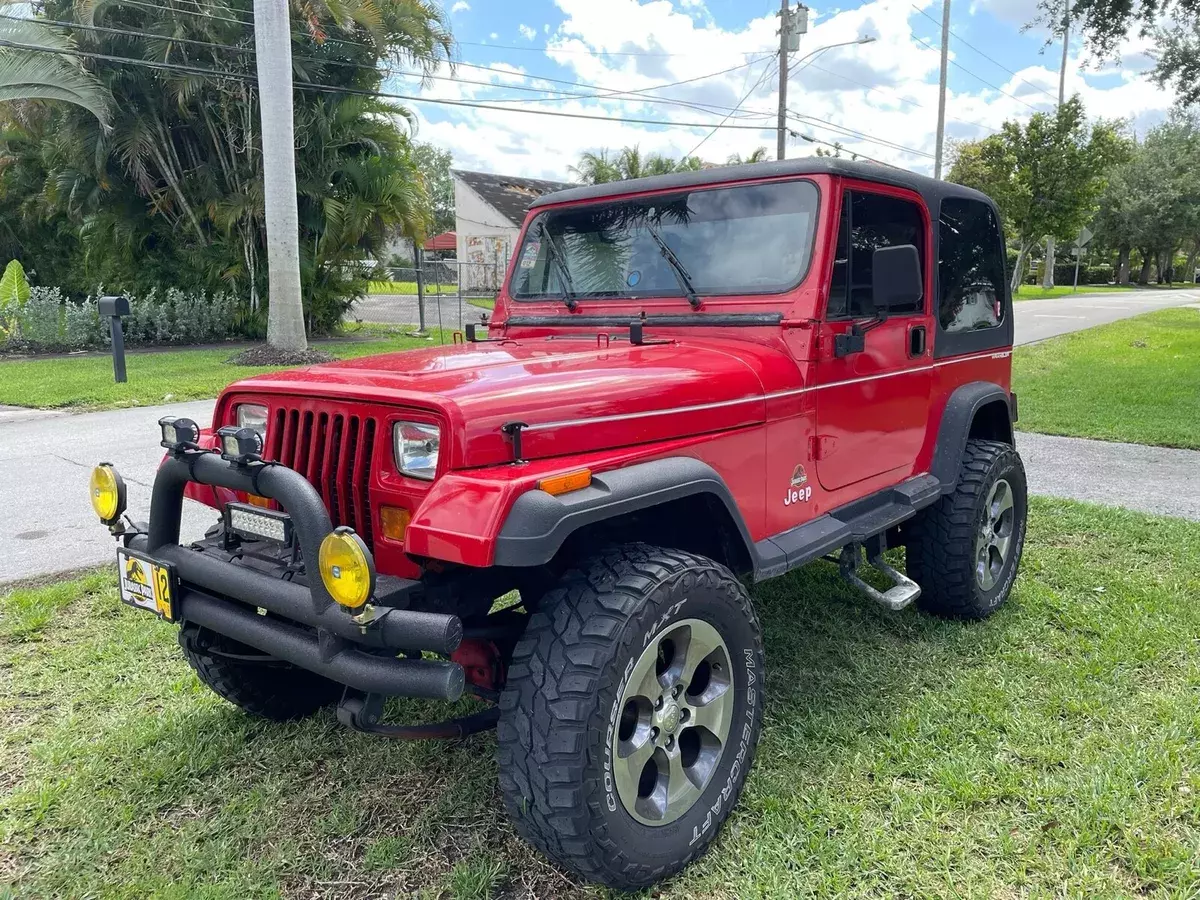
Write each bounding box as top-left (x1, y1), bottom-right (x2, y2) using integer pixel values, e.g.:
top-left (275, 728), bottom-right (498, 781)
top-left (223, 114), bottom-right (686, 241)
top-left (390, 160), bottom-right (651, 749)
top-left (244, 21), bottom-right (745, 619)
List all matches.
top-left (1013, 308), bottom-right (1200, 449)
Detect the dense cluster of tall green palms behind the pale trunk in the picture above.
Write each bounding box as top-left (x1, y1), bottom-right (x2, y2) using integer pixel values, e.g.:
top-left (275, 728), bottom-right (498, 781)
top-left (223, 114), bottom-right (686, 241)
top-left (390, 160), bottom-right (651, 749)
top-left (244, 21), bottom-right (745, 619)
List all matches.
top-left (0, 0), bottom-right (451, 334)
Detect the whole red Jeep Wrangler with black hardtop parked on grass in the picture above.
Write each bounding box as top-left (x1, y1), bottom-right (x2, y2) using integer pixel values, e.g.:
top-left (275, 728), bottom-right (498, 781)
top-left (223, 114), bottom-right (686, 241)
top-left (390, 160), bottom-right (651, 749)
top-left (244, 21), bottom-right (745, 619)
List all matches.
top-left (92, 158), bottom-right (1026, 888)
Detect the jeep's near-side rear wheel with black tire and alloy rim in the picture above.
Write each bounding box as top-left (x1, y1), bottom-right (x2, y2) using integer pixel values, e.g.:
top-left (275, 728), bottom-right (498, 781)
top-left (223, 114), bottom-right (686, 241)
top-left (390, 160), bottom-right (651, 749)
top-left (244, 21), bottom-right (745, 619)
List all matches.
top-left (905, 439), bottom-right (1028, 619)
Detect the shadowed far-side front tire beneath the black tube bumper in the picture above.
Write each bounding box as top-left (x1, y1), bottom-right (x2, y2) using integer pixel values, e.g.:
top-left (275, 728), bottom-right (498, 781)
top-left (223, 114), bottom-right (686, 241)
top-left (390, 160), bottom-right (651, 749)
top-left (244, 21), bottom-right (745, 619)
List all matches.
top-left (179, 624), bottom-right (342, 721)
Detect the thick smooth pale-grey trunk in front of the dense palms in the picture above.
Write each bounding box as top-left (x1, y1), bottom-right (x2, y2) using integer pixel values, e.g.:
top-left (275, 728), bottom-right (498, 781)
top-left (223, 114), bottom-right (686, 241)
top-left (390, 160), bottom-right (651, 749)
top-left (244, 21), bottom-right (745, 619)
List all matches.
top-left (254, 0), bottom-right (308, 352)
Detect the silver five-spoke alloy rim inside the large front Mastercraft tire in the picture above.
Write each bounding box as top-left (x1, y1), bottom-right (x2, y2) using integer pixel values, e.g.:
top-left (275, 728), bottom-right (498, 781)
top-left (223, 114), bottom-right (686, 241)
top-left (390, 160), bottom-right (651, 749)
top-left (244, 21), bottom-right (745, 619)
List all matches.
top-left (612, 619), bottom-right (734, 826)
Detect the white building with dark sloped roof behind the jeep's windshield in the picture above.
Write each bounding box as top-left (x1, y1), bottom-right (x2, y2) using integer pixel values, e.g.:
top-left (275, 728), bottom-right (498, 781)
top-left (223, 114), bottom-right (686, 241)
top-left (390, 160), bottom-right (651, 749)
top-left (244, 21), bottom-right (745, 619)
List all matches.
top-left (450, 169), bottom-right (577, 292)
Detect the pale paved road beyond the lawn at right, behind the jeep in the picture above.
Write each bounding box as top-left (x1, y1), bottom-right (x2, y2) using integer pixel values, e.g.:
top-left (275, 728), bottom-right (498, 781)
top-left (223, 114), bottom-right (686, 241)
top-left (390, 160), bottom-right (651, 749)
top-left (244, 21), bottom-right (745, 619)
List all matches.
top-left (1013, 289), bottom-right (1200, 344)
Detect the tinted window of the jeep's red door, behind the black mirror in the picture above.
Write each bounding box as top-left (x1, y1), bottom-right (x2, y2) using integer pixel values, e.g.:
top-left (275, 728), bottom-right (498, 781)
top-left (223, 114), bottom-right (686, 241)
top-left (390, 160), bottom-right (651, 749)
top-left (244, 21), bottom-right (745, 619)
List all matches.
top-left (828, 191), bottom-right (925, 319)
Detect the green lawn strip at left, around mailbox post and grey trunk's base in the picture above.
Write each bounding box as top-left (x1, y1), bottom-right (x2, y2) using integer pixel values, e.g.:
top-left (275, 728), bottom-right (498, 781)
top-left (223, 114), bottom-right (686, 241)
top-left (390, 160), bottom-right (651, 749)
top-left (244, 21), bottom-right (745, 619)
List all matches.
top-left (0, 325), bottom-right (438, 409)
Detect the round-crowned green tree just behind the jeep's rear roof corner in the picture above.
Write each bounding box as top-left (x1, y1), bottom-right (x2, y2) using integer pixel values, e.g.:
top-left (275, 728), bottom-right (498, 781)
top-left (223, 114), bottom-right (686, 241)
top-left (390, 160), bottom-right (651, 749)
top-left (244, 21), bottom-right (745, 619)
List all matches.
top-left (948, 97), bottom-right (1129, 293)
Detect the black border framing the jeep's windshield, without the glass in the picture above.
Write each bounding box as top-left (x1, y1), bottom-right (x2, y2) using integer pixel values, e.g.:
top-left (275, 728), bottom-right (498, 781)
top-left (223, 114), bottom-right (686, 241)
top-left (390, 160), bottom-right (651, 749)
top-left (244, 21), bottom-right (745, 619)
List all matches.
top-left (503, 175), bottom-right (824, 304)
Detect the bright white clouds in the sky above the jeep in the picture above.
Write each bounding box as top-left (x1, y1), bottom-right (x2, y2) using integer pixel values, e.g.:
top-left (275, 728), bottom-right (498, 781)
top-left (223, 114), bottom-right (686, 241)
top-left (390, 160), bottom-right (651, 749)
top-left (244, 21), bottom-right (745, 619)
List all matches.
top-left (406, 0), bottom-right (1174, 180)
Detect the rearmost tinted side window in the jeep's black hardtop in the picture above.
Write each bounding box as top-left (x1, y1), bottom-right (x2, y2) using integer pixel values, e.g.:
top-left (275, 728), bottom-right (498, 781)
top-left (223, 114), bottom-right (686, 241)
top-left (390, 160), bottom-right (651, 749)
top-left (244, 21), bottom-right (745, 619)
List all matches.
top-left (937, 199), bottom-right (1004, 332)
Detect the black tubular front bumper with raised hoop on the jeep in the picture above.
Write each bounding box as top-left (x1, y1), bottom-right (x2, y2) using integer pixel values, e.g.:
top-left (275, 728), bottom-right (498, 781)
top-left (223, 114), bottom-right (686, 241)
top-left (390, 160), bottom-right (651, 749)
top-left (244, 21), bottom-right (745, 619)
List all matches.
top-left (128, 451), bottom-right (464, 700)
